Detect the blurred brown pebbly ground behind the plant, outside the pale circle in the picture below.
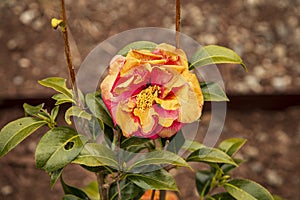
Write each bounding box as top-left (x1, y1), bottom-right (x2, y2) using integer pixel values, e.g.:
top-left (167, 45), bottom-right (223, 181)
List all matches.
top-left (0, 0), bottom-right (300, 200)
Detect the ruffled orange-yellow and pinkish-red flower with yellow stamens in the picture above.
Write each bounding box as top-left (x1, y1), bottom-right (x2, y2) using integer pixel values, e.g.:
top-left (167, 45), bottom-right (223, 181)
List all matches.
top-left (100, 43), bottom-right (203, 139)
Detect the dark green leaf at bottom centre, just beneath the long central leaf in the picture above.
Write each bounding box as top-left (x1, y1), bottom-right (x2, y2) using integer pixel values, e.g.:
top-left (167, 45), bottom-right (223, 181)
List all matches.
top-left (127, 169), bottom-right (178, 191)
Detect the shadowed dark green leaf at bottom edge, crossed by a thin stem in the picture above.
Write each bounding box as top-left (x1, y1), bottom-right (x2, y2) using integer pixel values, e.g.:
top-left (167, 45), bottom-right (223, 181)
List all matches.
top-left (109, 180), bottom-right (144, 200)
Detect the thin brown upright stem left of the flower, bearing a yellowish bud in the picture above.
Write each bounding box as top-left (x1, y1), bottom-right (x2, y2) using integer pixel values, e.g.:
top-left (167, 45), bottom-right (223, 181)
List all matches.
top-left (60, 0), bottom-right (79, 103)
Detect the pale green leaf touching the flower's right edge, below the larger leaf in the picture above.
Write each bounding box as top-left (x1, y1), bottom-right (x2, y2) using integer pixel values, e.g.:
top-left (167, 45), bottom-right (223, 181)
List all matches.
top-left (200, 82), bottom-right (229, 102)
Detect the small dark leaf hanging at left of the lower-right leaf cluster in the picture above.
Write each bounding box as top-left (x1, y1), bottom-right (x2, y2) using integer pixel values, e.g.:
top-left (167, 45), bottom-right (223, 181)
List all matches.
top-left (196, 171), bottom-right (214, 197)
